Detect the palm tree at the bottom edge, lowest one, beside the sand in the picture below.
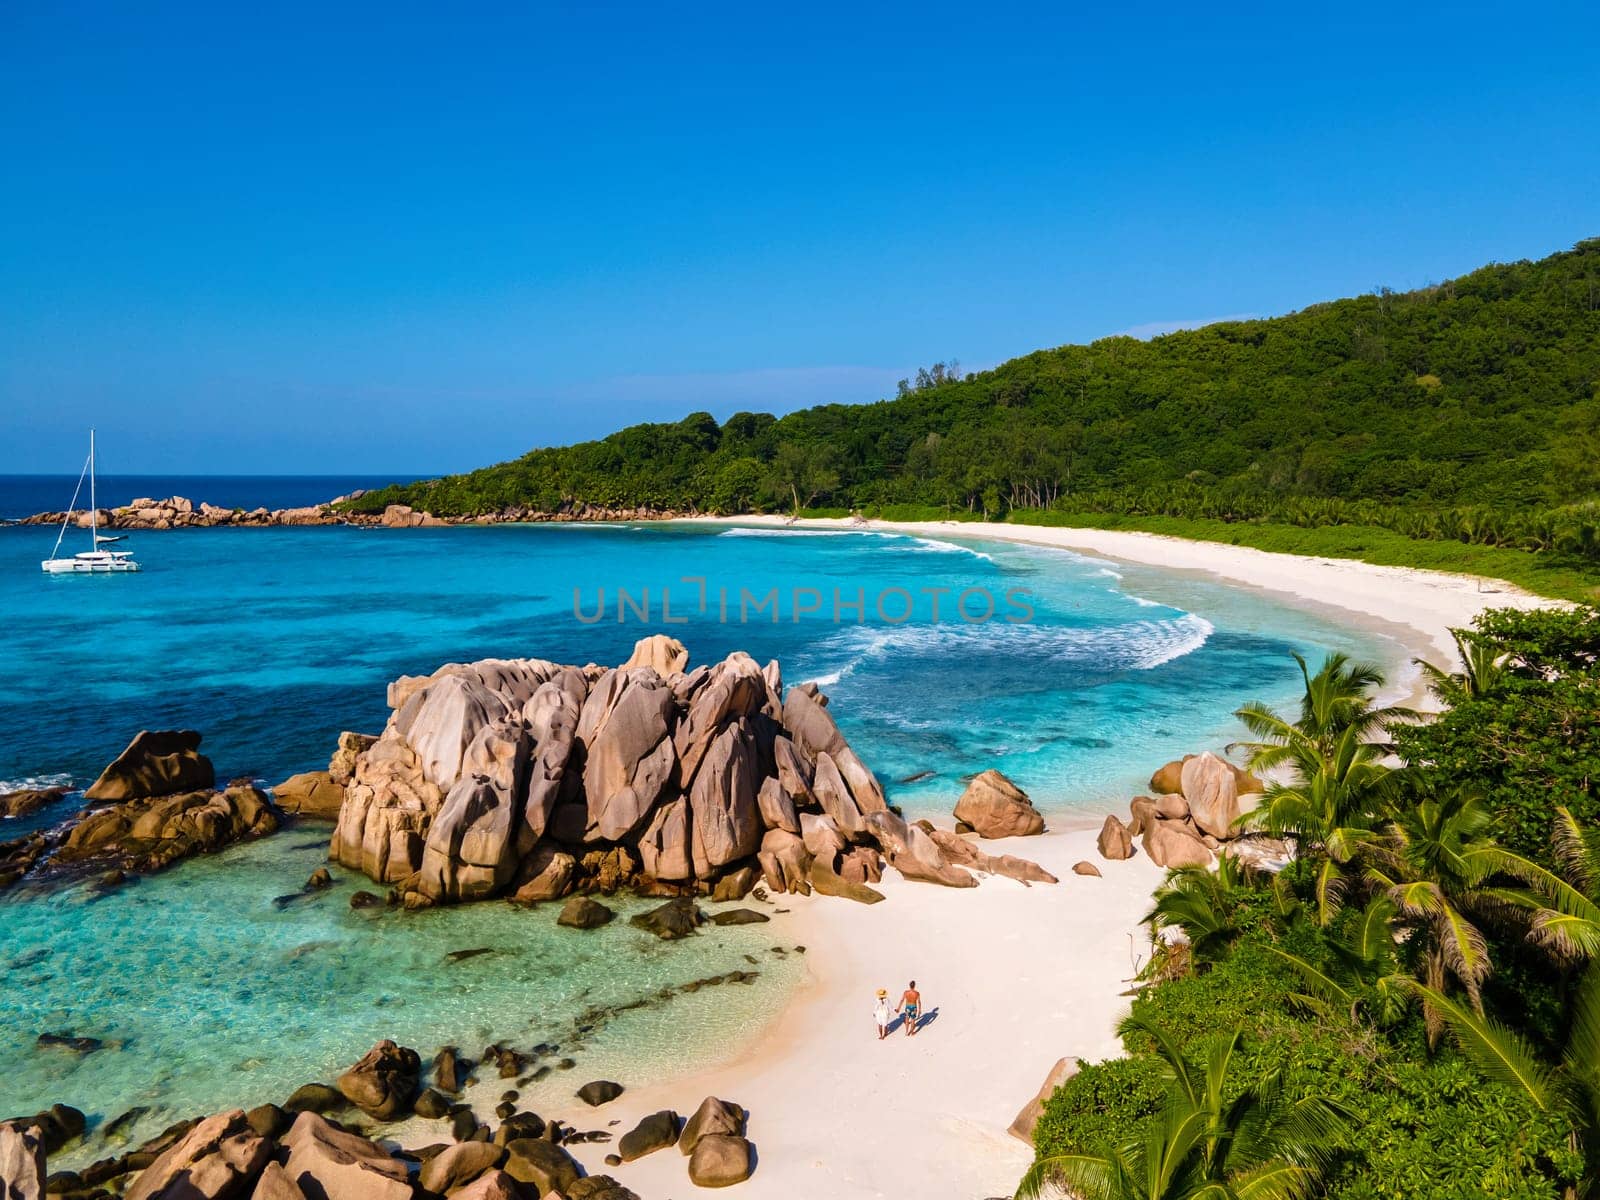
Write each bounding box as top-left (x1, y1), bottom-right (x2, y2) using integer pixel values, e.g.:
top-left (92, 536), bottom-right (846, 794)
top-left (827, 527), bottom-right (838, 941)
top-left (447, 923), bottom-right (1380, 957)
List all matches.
top-left (1016, 1016), bottom-right (1347, 1200)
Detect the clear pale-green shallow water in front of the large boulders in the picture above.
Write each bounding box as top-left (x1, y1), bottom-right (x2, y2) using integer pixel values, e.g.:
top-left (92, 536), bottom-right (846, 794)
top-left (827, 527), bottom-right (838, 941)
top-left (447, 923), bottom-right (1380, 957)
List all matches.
top-left (0, 826), bottom-right (803, 1165)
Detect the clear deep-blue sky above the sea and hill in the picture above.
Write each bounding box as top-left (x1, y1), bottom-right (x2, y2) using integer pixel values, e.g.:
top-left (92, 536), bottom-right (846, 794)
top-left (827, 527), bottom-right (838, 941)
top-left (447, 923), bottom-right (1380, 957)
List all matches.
top-left (0, 0), bottom-right (1600, 474)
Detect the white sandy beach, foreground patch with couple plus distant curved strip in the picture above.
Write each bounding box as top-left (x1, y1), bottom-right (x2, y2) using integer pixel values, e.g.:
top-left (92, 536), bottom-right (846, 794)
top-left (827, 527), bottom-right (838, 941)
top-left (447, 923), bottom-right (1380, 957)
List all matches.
top-left (441, 518), bottom-right (1549, 1200)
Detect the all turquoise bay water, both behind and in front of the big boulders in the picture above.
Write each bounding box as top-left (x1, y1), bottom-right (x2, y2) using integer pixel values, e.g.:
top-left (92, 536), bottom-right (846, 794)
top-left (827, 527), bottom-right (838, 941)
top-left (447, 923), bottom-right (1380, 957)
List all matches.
top-left (0, 526), bottom-right (1398, 1152)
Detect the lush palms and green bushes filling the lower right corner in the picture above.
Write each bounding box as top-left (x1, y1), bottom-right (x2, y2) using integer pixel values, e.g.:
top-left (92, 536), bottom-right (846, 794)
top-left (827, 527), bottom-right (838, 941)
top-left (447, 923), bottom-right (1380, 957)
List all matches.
top-left (1022, 608), bottom-right (1600, 1200)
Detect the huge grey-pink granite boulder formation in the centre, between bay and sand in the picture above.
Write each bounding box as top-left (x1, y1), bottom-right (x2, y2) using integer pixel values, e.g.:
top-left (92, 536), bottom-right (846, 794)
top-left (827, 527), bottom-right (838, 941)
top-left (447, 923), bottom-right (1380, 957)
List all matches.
top-left (300, 635), bottom-right (1054, 907)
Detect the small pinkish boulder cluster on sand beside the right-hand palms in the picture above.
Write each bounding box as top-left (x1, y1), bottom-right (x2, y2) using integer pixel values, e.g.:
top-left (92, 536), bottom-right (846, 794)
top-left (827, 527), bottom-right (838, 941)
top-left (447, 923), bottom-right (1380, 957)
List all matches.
top-left (1098, 750), bottom-right (1285, 869)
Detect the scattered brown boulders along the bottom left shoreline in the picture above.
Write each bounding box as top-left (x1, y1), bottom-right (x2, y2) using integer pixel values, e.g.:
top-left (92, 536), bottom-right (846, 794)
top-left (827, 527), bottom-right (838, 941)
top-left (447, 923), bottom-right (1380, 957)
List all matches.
top-left (0, 1040), bottom-right (755, 1200)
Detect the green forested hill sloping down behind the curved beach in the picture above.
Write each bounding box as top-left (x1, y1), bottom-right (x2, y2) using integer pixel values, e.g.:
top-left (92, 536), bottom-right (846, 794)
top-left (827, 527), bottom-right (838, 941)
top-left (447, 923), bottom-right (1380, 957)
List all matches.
top-left (358, 238), bottom-right (1600, 576)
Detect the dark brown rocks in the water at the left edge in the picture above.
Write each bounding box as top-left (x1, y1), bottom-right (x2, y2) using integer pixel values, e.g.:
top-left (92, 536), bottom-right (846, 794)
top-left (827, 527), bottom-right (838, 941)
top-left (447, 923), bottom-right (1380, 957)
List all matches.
top-left (0, 730), bottom-right (278, 888)
